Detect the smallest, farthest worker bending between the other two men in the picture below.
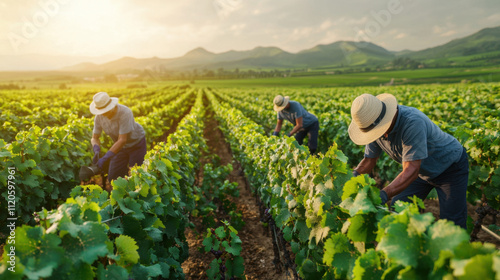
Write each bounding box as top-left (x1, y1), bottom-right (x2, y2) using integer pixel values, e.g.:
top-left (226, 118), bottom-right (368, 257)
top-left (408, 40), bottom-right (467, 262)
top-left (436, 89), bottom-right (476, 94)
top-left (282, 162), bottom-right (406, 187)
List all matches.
top-left (273, 95), bottom-right (319, 155)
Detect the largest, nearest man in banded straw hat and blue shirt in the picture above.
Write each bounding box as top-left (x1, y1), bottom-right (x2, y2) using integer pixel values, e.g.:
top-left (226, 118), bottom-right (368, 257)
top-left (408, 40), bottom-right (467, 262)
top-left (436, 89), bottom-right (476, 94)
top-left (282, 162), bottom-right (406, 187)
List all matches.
top-left (349, 93), bottom-right (469, 228)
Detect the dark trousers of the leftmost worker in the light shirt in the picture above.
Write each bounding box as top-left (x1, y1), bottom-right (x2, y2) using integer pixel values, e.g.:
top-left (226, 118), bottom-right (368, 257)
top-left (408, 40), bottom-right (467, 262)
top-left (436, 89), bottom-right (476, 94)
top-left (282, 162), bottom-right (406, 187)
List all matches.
top-left (108, 138), bottom-right (147, 182)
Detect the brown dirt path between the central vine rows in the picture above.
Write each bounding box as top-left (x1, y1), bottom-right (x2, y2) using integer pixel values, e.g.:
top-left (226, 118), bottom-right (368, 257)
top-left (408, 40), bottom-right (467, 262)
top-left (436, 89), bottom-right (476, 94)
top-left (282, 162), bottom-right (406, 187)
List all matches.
top-left (182, 106), bottom-right (291, 280)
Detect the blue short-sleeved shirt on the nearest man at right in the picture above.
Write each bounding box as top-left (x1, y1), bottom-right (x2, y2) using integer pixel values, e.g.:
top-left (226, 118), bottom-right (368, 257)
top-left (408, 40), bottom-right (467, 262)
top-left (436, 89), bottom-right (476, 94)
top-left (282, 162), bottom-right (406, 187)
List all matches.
top-left (365, 105), bottom-right (463, 181)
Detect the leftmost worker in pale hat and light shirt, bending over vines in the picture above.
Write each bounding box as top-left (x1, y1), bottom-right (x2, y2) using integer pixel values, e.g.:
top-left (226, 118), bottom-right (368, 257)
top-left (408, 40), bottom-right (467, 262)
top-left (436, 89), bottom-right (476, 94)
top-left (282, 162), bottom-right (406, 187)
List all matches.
top-left (90, 92), bottom-right (146, 182)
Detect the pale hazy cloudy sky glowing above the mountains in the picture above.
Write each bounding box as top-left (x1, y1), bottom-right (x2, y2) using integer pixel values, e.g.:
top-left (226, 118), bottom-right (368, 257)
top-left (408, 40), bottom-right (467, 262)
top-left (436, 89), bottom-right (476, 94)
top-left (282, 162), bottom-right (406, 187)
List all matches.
top-left (0, 0), bottom-right (500, 58)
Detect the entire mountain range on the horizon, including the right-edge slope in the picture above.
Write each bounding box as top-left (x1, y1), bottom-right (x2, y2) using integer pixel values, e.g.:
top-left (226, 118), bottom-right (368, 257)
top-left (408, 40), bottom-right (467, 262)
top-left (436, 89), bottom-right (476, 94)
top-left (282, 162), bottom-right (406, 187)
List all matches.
top-left (62, 24), bottom-right (500, 72)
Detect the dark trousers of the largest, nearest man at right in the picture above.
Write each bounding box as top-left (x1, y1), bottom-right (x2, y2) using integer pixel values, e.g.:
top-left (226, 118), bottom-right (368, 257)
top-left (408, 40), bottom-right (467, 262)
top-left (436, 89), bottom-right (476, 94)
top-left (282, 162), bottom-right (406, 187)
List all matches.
top-left (391, 148), bottom-right (469, 229)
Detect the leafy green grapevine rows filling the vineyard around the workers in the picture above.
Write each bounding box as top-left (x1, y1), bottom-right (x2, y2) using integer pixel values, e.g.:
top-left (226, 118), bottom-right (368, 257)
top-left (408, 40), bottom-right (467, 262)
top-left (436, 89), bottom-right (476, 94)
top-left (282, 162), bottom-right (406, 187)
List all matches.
top-left (0, 82), bottom-right (500, 279)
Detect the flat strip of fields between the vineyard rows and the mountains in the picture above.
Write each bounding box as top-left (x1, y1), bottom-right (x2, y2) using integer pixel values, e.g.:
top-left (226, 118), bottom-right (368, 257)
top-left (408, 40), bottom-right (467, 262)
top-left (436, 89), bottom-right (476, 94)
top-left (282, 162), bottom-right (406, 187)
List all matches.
top-left (0, 67), bottom-right (500, 89)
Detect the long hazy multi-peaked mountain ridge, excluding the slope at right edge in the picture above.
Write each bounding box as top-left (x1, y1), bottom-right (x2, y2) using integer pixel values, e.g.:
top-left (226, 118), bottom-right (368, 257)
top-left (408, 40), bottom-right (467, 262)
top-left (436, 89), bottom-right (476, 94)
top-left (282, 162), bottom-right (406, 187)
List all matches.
top-left (63, 41), bottom-right (395, 72)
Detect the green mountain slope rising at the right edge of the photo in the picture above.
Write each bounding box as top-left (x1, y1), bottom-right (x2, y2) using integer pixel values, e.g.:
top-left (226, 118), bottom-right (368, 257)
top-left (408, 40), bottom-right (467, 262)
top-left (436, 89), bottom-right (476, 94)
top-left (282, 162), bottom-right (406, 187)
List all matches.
top-left (399, 26), bottom-right (500, 60)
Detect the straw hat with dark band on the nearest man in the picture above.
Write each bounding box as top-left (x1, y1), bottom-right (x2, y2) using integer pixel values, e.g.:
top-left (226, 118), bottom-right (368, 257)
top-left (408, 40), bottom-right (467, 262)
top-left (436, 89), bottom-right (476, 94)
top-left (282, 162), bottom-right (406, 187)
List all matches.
top-left (348, 93), bottom-right (398, 145)
